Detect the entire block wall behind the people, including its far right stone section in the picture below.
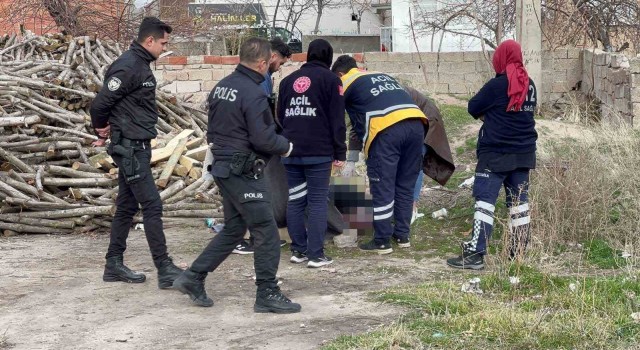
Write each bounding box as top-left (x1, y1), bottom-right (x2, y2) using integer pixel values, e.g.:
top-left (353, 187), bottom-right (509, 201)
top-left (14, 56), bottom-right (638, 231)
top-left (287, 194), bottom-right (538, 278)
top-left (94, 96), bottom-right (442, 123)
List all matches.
top-left (153, 49), bottom-right (640, 127)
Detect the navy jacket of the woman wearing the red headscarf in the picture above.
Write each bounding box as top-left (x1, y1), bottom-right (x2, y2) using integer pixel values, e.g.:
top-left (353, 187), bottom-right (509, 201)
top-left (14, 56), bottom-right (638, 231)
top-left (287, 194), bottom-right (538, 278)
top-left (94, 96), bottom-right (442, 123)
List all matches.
top-left (468, 74), bottom-right (538, 154)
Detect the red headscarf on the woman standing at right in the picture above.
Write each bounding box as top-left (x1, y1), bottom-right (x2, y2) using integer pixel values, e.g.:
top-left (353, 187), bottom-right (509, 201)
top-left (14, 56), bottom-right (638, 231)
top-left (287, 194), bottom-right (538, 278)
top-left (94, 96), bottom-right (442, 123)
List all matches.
top-left (493, 40), bottom-right (529, 112)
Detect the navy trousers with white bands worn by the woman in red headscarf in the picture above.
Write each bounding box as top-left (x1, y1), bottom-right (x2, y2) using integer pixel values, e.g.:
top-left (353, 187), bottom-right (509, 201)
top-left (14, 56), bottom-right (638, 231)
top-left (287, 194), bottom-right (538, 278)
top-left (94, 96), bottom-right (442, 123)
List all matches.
top-left (464, 168), bottom-right (530, 256)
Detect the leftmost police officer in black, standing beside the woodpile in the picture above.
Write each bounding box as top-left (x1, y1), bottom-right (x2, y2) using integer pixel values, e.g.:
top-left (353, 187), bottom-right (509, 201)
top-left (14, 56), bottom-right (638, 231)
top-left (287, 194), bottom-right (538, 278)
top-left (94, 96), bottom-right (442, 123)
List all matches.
top-left (91, 17), bottom-right (182, 289)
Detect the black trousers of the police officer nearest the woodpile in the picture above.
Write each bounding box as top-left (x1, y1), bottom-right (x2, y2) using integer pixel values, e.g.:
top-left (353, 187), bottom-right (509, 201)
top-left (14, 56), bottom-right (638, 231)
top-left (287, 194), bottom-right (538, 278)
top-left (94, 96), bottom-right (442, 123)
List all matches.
top-left (106, 143), bottom-right (168, 267)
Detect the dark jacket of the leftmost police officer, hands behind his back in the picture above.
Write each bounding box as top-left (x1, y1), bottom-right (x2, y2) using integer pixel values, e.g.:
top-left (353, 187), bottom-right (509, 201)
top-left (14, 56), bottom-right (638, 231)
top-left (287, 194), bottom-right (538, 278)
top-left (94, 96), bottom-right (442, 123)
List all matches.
top-left (90, 41), bottom-right (158, 140)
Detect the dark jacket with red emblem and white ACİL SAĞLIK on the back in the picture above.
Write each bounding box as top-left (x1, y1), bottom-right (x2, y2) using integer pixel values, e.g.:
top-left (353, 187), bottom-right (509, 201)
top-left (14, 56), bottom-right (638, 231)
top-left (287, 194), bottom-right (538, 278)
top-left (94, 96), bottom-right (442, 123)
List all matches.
top-left (277, 57), bottom-right (347, 161)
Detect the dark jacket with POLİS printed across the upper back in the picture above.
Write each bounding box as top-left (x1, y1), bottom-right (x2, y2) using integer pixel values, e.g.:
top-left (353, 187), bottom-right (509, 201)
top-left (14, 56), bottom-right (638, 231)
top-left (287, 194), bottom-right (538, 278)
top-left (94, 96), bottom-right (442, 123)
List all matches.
top-left (207, 64), bottom-right (289, 159)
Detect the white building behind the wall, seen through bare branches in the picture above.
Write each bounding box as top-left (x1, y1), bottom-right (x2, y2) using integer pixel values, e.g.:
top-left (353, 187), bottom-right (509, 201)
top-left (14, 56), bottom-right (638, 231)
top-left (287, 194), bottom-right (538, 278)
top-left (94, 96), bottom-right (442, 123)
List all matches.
top-left (388, 0), bottom-right (482, 52)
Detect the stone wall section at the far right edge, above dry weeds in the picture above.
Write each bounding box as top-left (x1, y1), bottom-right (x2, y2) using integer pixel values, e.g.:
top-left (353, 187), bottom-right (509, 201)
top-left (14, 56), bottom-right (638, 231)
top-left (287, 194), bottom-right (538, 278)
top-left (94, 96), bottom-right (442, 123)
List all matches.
top-left (582, 49), bottom-right (640, 128)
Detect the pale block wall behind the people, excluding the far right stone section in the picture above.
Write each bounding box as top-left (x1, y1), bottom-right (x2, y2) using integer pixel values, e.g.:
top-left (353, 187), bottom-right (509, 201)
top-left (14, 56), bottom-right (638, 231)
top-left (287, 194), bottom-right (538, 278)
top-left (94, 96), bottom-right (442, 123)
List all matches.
top-left (156, 49), bottom-right (582, 102)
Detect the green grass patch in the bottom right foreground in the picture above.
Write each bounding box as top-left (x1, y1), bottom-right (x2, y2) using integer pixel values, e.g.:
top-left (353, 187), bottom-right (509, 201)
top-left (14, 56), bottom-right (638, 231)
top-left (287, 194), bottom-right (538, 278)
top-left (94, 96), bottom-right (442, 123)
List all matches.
top-left (325, 264), bottom-right (640, 350)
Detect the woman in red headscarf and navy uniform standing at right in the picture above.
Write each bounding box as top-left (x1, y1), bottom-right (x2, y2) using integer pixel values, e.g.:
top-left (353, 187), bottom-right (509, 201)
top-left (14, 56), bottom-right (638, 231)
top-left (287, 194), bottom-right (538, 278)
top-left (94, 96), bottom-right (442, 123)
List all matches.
top-left (447, 40), bottom-right (538, 270)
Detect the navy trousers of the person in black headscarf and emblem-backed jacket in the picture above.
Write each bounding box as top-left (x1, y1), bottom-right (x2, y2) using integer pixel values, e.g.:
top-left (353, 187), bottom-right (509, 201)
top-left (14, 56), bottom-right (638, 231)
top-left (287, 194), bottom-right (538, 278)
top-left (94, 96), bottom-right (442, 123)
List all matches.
top-left (285, 162), bottom-right (331, 259)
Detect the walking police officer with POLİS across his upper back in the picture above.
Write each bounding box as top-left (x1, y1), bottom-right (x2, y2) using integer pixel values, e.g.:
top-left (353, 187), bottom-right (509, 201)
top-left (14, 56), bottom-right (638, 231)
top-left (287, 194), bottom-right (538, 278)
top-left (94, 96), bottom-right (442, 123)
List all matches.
top-left (173, 38), bottom-right (301, 313)
